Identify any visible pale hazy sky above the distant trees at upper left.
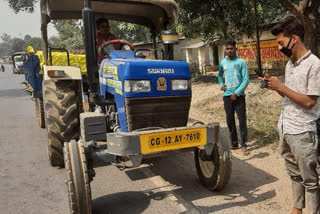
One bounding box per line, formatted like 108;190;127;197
0;0;57;42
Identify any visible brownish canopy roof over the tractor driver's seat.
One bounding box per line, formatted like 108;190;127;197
40;0;178;33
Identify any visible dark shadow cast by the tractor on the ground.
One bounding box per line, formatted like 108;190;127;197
93;124;278;214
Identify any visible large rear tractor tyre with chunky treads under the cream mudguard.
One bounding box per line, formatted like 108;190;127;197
43;80;79;167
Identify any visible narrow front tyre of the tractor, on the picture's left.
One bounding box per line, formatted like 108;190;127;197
64;140;91;214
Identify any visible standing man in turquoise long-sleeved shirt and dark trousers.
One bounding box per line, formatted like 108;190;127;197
218;40;249;155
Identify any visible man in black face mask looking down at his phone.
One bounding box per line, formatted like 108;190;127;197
259;16;320;214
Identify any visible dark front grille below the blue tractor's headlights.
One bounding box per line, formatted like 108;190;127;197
125;95;191;132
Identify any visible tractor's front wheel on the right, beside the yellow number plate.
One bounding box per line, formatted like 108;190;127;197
194;133;232;191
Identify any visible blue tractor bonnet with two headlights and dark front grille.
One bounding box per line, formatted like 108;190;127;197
99;51;191;132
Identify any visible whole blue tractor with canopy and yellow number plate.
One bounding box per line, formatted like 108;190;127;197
40;0;231;214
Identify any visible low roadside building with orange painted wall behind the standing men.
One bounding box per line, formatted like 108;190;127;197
134;24;288;73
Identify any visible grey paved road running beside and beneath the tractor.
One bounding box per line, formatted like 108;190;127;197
0;66;281;214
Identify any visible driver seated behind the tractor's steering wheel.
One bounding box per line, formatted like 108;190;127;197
96;17;120;62
